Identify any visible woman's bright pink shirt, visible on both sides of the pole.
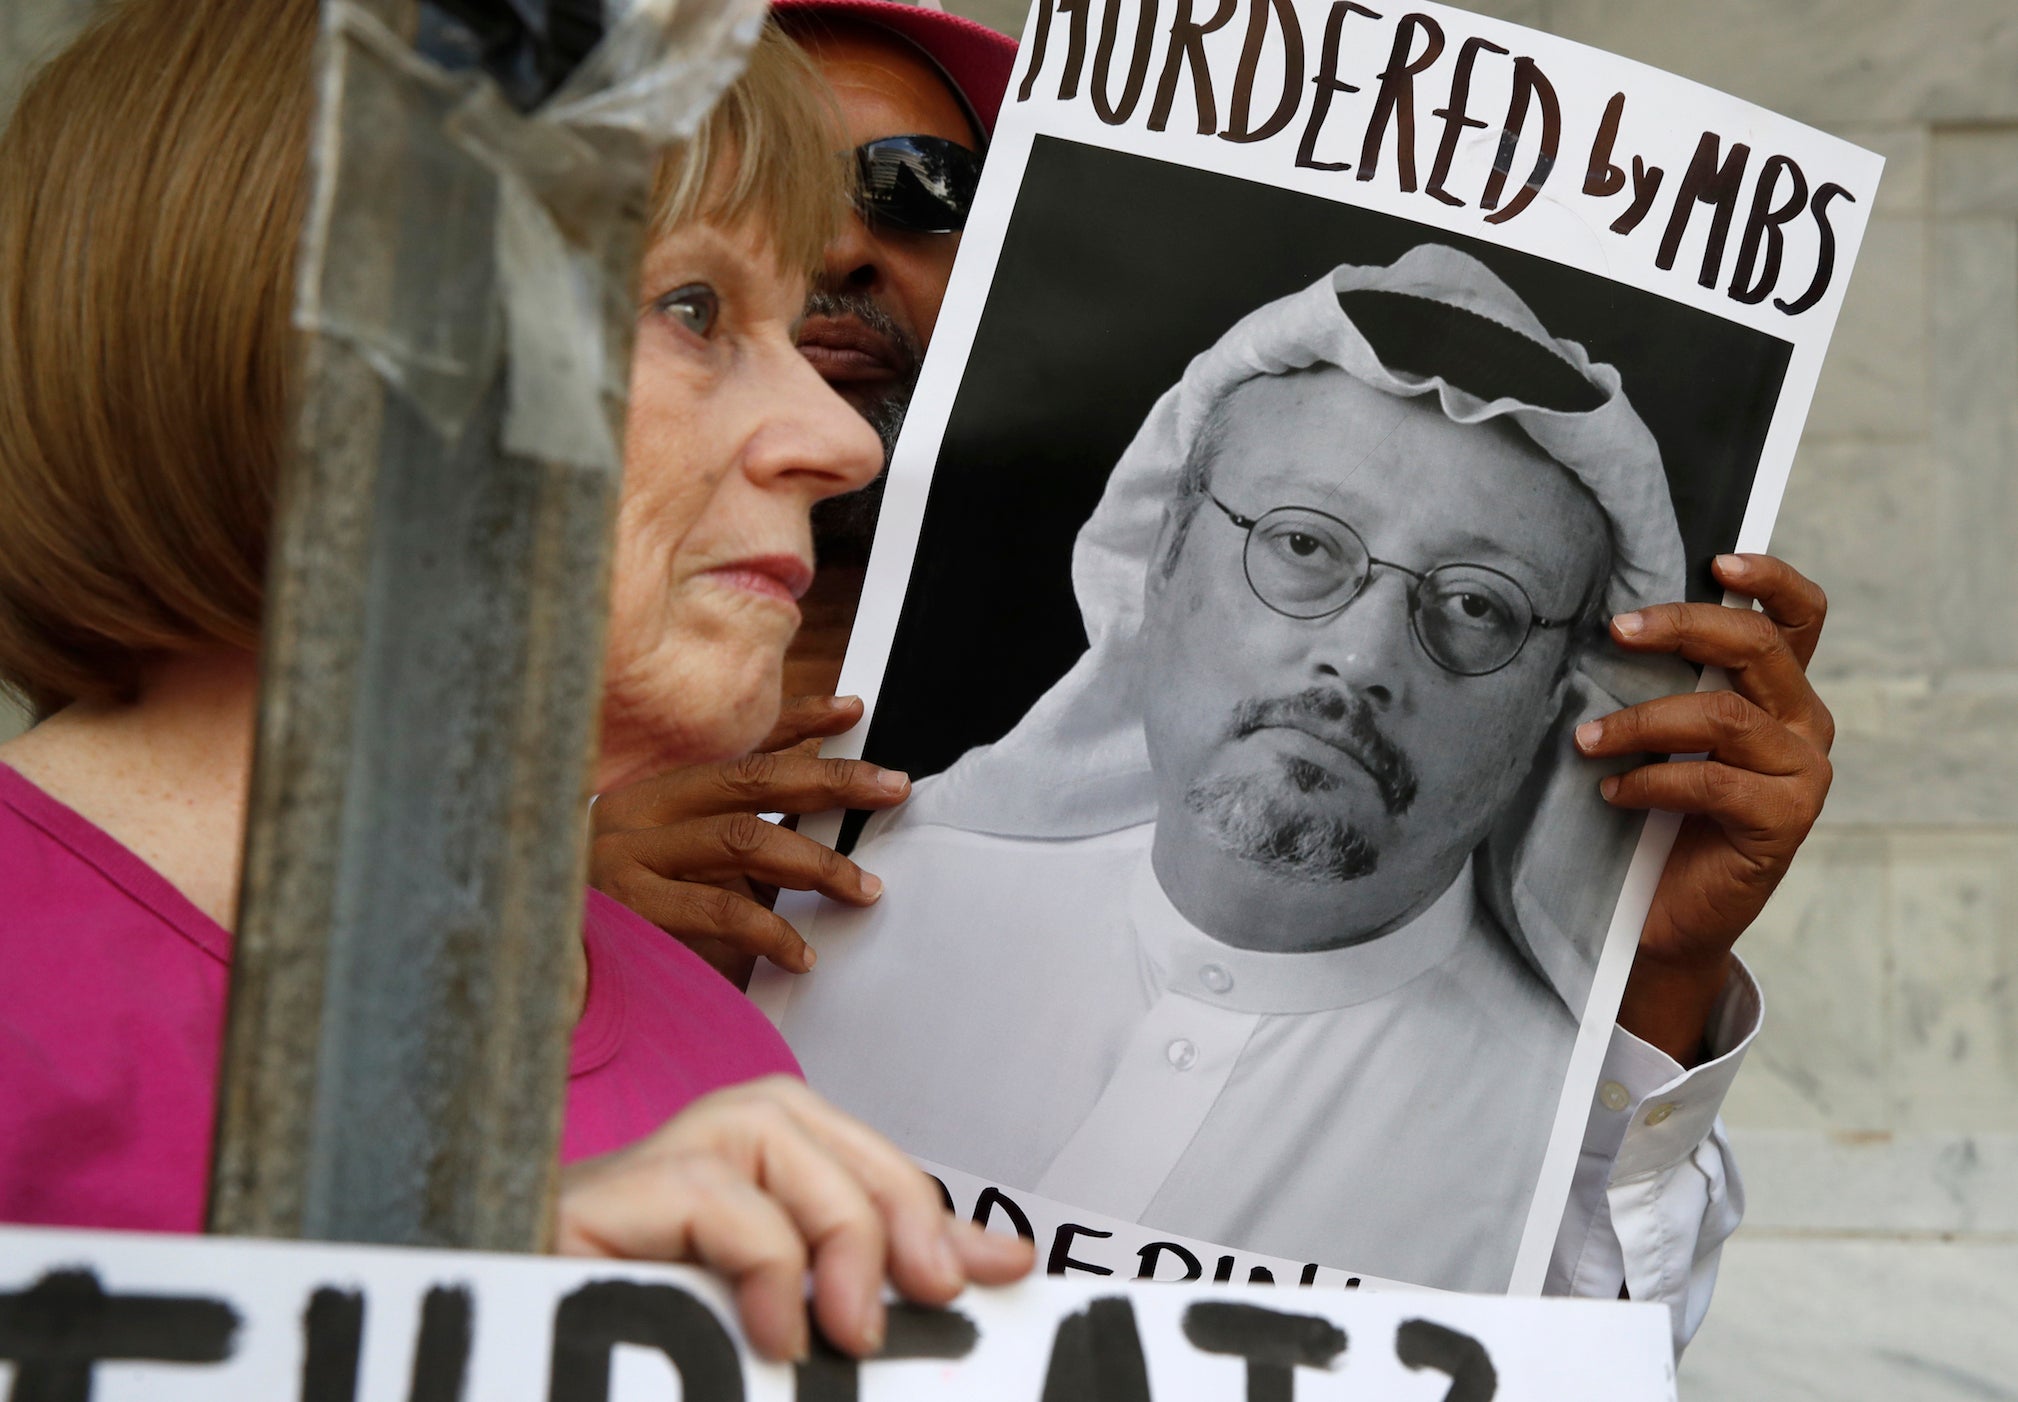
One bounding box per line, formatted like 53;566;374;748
0;765;799;1233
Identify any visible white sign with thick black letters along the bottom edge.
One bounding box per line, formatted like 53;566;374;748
0;1229;1675;1402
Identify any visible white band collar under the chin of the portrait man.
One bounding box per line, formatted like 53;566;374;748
1128;845;1477;1013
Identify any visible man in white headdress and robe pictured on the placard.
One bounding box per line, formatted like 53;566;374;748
783;244;1691;1289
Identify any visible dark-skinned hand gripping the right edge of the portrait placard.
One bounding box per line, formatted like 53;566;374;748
1576;555;1836;1065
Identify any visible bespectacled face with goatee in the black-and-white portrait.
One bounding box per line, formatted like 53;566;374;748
1140;367;1608;934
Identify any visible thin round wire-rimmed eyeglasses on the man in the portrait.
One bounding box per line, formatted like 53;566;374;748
1207;492;1572;676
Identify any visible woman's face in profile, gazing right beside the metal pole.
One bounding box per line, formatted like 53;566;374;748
597;224;882;789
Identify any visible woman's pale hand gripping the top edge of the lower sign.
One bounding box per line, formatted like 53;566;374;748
555;1077;1035;1360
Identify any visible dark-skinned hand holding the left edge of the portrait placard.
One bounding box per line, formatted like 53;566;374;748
589;696;910;984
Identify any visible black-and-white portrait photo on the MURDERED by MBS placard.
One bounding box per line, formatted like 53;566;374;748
781;139;1786;1291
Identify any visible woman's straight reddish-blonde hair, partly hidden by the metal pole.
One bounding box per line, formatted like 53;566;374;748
0;0;848;714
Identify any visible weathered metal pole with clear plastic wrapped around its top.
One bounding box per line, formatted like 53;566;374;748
210;0;761;1251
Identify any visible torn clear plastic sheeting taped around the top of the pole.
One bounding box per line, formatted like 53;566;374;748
295;0;763;472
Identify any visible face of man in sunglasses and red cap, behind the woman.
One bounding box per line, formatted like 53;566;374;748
799;22;977;494
